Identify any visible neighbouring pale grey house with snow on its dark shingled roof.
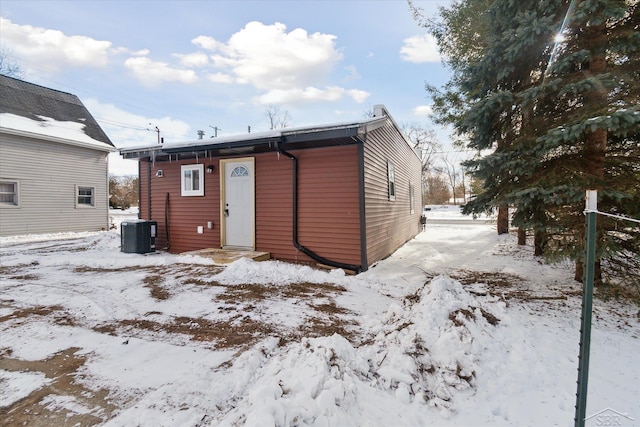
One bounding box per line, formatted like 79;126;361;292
0;76;115;236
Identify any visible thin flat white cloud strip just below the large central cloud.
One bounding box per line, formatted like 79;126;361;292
253;86;370;105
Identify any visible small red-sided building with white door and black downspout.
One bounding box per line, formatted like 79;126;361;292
120;105;422;272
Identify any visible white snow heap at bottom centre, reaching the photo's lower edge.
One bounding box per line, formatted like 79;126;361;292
212;335;369;426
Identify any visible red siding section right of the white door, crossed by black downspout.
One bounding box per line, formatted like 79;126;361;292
256;145;360;265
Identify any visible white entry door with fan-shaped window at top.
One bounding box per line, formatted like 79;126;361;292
220;157;255;249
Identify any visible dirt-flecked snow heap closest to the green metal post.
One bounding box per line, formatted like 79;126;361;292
364;276;499;417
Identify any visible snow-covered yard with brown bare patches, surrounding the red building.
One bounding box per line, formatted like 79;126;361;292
0;207;640;427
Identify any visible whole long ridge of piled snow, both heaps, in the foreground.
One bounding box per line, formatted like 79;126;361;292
202;276;499;426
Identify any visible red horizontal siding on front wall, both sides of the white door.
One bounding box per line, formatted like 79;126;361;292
139;145;360;264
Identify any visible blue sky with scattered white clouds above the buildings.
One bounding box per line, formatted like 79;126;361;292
0;0;450;174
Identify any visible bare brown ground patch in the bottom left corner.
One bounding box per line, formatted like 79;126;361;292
0;348;118;427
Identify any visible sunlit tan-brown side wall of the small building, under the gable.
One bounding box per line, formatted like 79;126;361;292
364;120;422;265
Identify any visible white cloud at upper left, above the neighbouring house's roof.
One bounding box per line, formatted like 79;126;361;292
0;17;115;72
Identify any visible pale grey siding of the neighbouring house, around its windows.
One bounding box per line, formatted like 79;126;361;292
0;133;109;236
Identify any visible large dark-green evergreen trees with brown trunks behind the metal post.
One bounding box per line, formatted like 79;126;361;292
410;0;640;290
